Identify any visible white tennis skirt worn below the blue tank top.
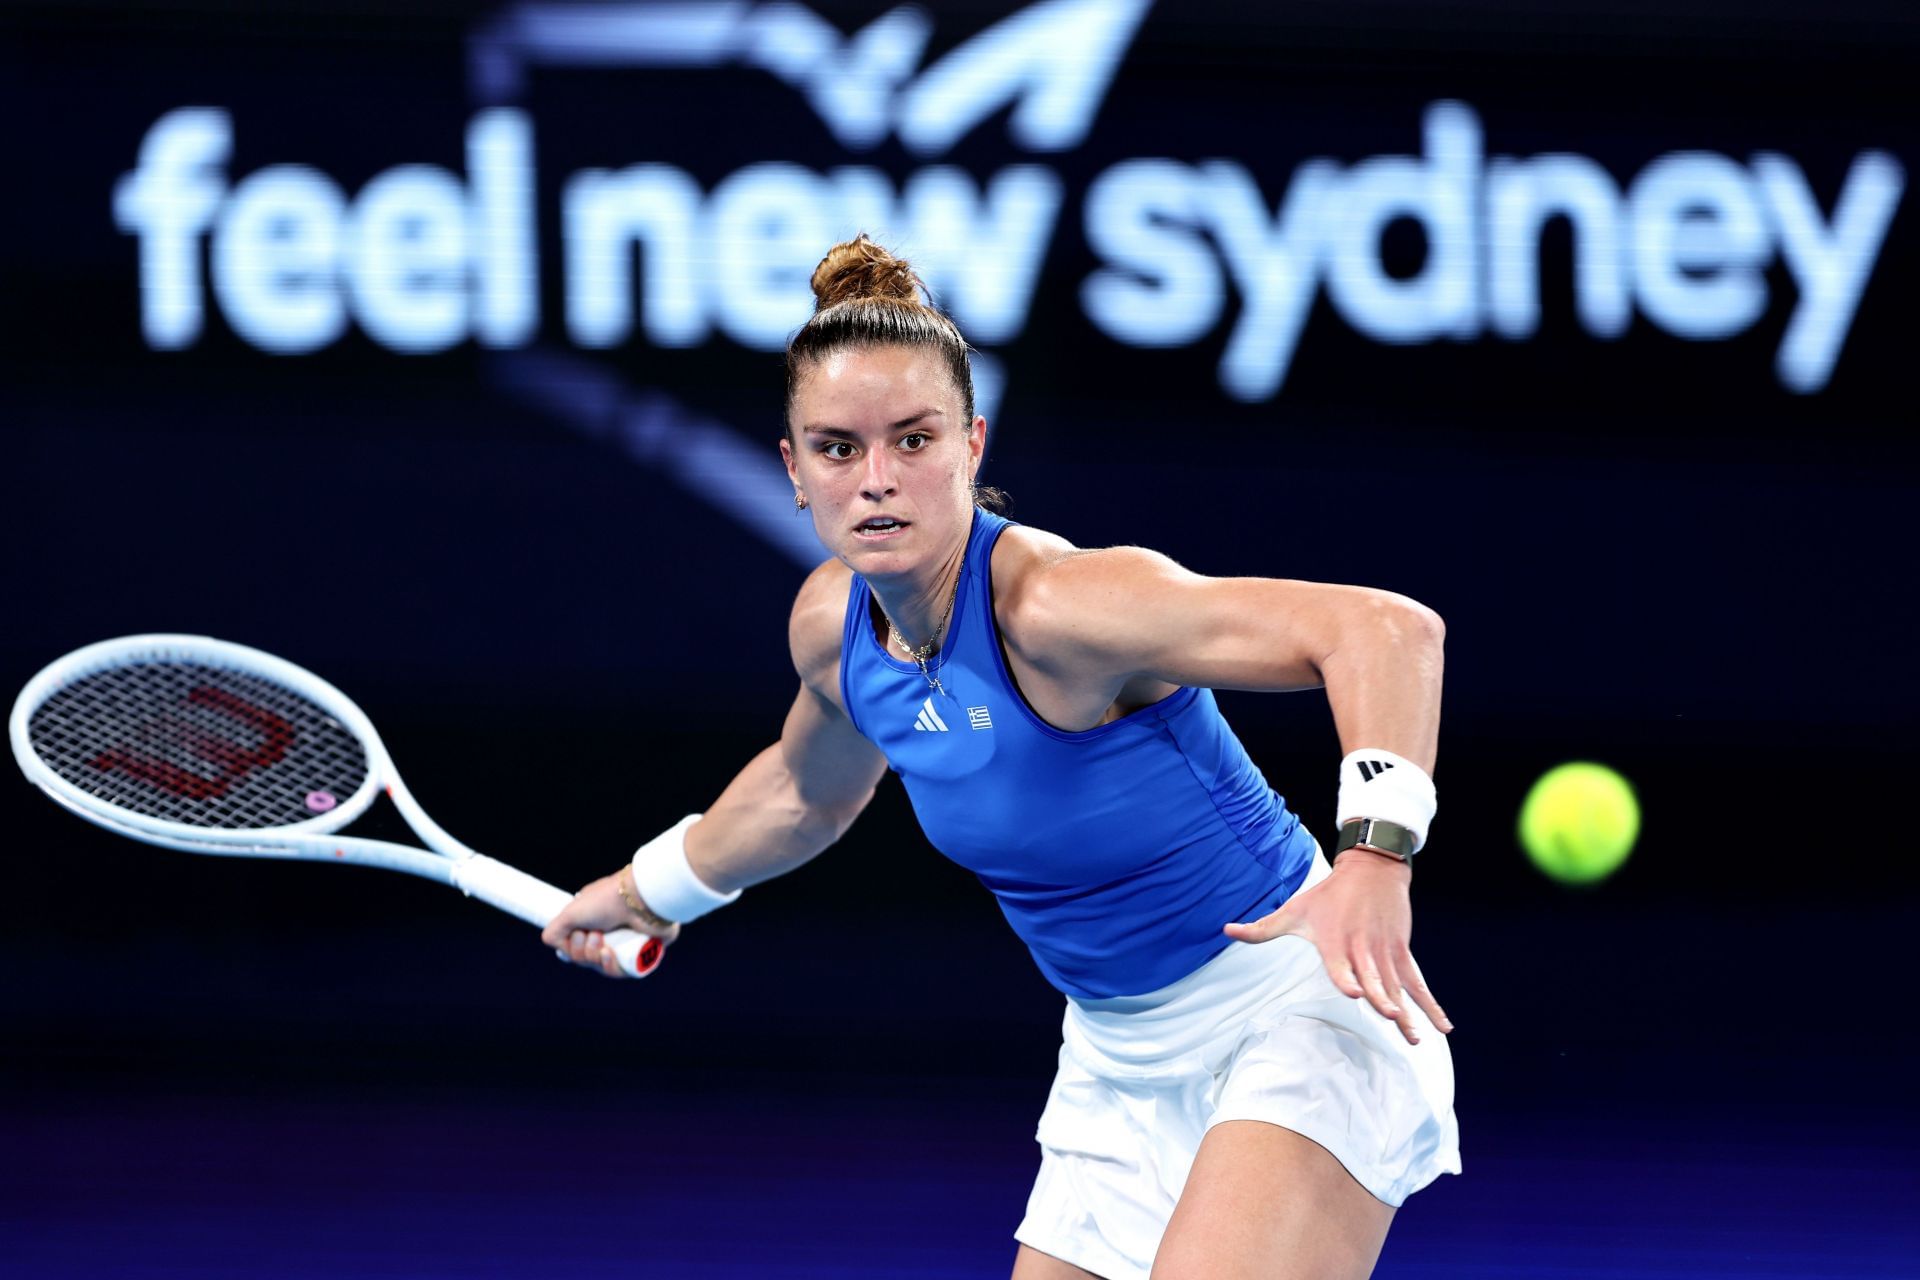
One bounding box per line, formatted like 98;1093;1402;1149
1014;846;1459;1280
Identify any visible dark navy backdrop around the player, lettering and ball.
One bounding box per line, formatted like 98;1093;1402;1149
0;0;1920;1276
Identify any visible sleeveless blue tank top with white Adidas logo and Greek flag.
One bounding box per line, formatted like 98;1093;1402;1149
841;510;1313;1000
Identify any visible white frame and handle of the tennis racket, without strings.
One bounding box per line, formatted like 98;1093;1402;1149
8;633;659;977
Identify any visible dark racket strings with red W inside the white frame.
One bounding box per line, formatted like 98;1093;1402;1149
27;660;369;829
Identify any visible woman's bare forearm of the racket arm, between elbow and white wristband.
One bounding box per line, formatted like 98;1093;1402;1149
687;743;874;892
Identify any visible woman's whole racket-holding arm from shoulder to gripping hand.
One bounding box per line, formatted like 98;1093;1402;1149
541;562;887;977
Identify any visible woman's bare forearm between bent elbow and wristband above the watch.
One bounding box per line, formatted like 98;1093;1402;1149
1319;591;1446;773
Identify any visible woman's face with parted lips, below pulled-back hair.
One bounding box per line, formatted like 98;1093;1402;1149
780;347;987;578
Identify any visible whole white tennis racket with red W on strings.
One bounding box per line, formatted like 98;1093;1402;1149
8;635;664;977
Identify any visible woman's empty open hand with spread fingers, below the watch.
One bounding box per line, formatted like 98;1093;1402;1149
1227;848;1453;1044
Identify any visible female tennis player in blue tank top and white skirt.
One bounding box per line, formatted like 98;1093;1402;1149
543;236;1459;1280
